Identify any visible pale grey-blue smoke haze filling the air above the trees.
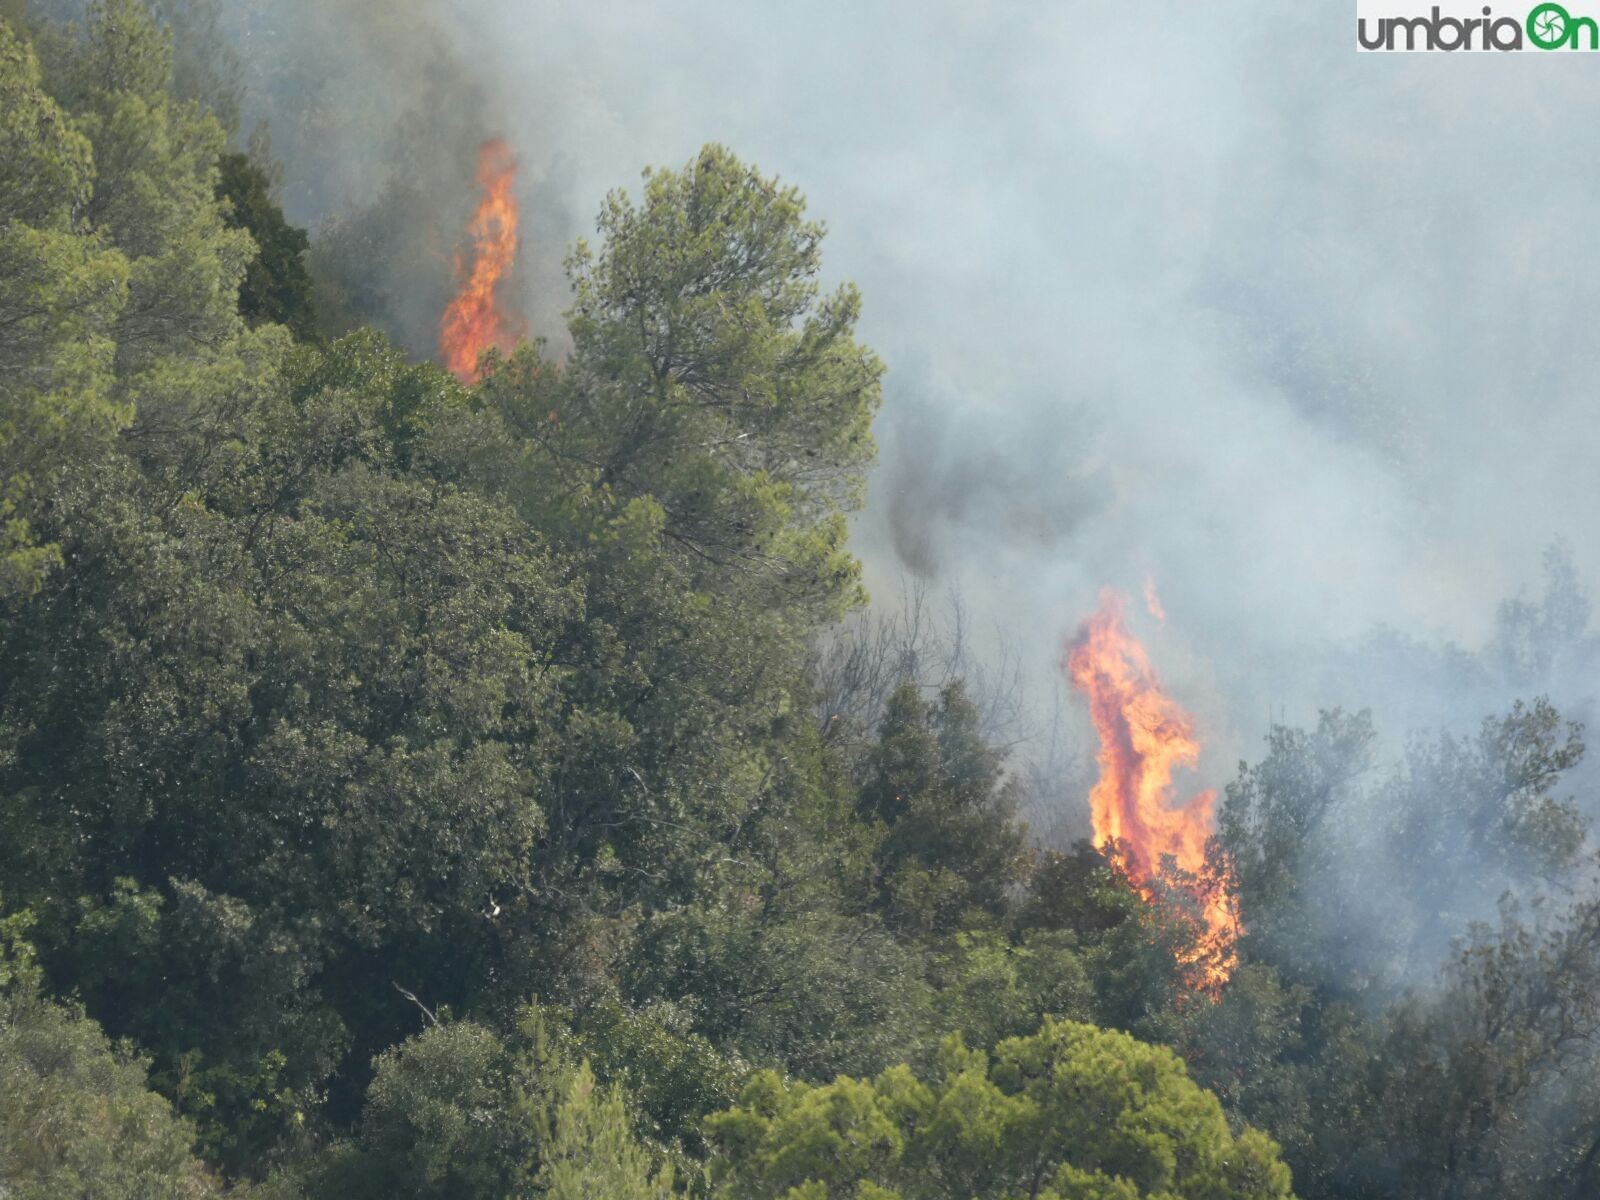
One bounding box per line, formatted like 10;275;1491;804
219;0;1600;779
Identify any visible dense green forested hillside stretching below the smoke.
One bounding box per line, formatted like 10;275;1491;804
0;0;1600;1200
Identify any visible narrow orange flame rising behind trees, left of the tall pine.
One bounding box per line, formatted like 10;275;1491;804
438;138;523;384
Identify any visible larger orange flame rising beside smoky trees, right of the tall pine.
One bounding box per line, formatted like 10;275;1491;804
1064;589;1240;989
